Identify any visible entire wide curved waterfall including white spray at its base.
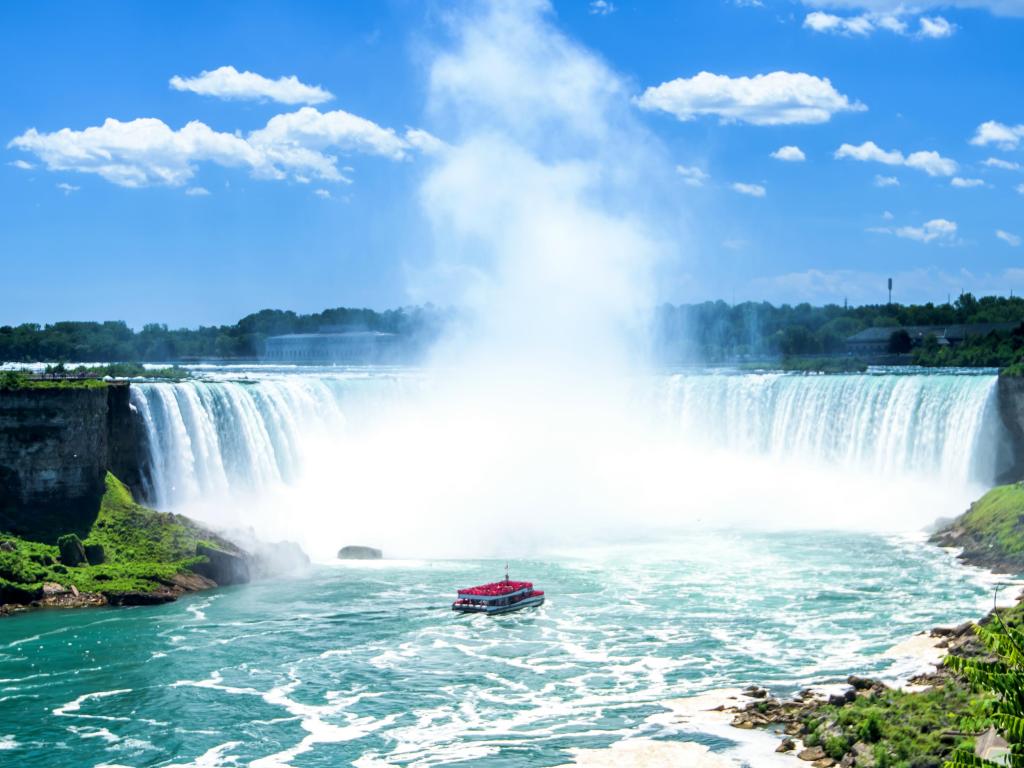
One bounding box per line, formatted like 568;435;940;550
133;374;1002;558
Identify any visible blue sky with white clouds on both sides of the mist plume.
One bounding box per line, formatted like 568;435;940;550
0;0;1024;326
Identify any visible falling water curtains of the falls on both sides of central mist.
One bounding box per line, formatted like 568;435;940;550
132;373;1001;518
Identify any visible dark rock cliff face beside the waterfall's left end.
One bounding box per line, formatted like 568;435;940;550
0;385;140;541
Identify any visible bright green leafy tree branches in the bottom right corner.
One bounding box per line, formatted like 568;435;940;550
945;611;1024;768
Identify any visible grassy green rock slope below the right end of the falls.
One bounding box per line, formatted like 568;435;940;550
932;482;1024;572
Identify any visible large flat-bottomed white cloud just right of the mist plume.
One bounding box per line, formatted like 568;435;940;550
637;72;867;125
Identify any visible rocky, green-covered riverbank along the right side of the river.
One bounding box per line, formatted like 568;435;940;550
696;482;1024;768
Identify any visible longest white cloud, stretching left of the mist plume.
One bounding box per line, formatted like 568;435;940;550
7;106;429;187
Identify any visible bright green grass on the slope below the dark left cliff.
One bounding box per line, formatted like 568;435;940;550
0;473;209;602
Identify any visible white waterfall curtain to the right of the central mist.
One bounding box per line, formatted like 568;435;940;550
658;373;1002;483
